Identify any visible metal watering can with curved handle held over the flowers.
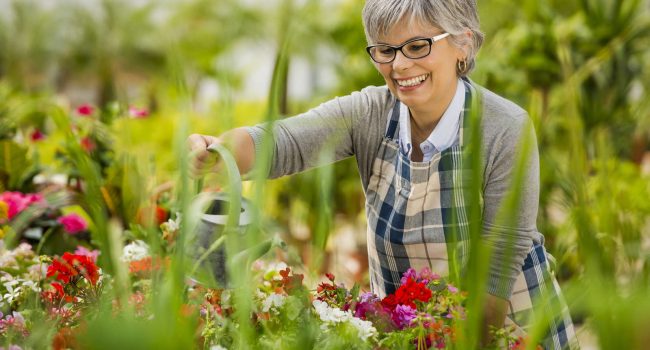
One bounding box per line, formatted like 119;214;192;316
190;144;286;288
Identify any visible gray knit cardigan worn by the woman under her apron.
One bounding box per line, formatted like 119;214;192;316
248;84;543;299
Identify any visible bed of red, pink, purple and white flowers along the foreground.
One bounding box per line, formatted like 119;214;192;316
0;189;540;349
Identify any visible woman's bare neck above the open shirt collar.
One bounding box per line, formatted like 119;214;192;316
409;80;458;139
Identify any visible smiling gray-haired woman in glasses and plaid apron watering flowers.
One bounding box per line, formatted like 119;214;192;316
188;0;577;349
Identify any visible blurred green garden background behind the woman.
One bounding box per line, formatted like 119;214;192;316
0;0;650;347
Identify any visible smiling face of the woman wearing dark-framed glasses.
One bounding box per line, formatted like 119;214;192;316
375;20;466;112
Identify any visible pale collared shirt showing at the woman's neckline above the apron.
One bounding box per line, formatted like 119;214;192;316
399;79;465;162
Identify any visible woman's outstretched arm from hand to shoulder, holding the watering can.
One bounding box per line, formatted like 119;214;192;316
188;87;394;184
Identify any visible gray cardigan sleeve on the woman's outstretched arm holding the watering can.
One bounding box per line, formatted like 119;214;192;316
247;87;387;178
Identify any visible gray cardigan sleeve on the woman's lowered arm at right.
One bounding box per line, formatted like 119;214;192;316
483;112;541;299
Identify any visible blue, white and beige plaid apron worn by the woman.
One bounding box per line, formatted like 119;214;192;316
366;80;578;349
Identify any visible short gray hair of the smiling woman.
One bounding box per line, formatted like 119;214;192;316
362;0;484;76
